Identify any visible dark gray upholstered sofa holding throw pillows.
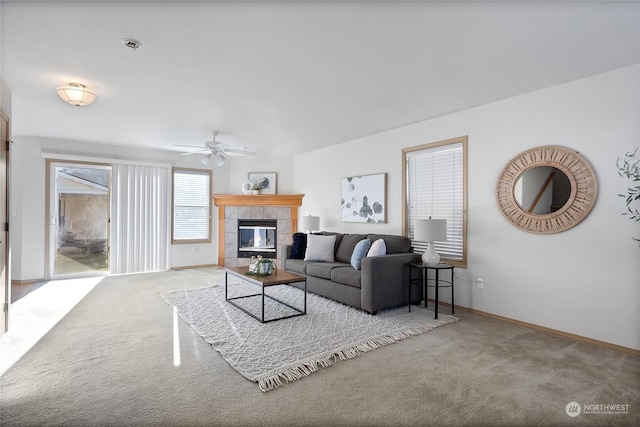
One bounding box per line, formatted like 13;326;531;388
281;232;422;314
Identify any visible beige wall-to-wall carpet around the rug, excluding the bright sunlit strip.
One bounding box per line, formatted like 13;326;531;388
0;268;640;427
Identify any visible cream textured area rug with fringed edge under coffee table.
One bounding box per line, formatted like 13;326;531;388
160;283;458;392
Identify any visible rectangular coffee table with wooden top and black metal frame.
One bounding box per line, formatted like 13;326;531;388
224;267;307;323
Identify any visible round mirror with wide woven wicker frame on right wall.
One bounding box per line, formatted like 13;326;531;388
496;145;597;234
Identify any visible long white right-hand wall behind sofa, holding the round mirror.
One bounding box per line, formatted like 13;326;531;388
293;65;640;349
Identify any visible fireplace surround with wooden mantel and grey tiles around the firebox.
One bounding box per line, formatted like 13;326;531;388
212;194;304;267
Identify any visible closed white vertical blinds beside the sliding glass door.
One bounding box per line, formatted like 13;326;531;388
111;164;171;274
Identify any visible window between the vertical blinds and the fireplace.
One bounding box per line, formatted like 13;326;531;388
171;169;211;243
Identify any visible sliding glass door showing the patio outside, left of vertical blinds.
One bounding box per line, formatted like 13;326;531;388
49;163;111;278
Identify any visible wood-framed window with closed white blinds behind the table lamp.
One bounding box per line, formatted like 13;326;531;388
402;136;467;268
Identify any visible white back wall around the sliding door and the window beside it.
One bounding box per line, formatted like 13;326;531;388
10;136;229;280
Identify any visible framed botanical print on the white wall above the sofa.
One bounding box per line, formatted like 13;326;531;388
341;173;387;224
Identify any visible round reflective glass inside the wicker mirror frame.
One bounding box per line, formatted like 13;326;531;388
513;166;571;215
